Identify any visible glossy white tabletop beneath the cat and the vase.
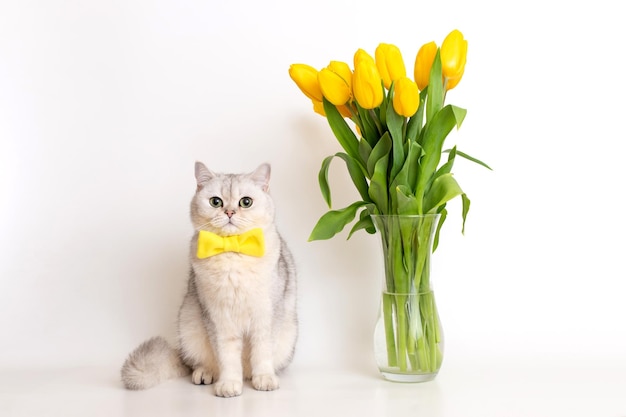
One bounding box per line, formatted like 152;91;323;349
0;357;626;417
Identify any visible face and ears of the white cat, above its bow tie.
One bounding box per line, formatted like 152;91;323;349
191;162;274;236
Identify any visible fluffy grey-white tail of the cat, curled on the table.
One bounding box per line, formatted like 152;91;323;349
121;336;190;390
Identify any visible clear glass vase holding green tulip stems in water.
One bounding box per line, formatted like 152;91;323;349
372;214;444;382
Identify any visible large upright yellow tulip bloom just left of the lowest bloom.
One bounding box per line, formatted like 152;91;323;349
352;49;383;109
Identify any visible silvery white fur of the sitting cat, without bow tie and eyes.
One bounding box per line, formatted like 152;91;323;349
121;162;298;397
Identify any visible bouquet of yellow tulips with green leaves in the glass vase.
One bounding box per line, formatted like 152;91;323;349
289;30;489;374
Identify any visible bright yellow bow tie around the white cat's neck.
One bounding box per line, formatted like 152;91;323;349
197;228;265;259
